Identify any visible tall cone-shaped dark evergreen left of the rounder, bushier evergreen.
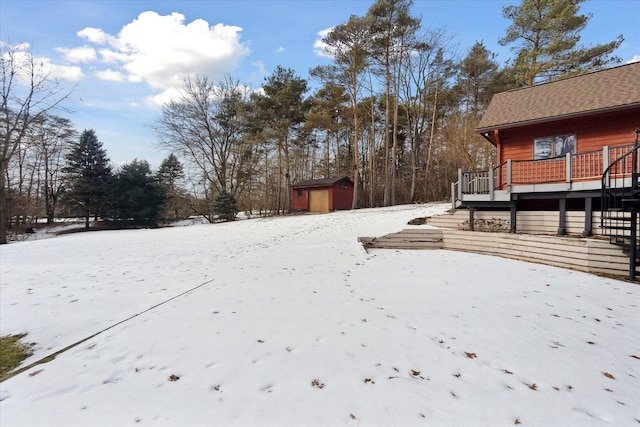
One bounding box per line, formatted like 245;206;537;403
64;129;111;228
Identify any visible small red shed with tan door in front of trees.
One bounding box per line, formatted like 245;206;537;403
291;176;353;212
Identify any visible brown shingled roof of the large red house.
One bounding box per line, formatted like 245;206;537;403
476;62;640;133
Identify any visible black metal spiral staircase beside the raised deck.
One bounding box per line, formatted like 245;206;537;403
600;129;640;281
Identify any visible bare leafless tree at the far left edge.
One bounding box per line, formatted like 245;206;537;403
0;42;73;244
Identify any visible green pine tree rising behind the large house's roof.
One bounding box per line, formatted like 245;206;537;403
500;0;624;86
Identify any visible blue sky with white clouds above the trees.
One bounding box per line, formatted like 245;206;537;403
0;0;640;167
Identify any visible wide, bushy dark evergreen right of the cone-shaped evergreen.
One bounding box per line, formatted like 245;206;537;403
110;160;166;224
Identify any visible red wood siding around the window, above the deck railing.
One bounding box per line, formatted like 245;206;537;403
498;109;640;163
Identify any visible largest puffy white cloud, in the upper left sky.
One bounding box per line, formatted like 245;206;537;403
78;11;249;100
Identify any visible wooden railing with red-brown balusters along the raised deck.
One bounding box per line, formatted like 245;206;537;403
452;144;633;200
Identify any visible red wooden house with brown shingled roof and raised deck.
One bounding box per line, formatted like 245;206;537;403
452;63;640;280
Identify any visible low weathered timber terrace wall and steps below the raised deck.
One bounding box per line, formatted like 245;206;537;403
358;228;629;279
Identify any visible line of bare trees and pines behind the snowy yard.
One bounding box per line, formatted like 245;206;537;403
0;0;623;244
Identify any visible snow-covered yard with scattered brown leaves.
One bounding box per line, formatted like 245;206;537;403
0;204;640;426
